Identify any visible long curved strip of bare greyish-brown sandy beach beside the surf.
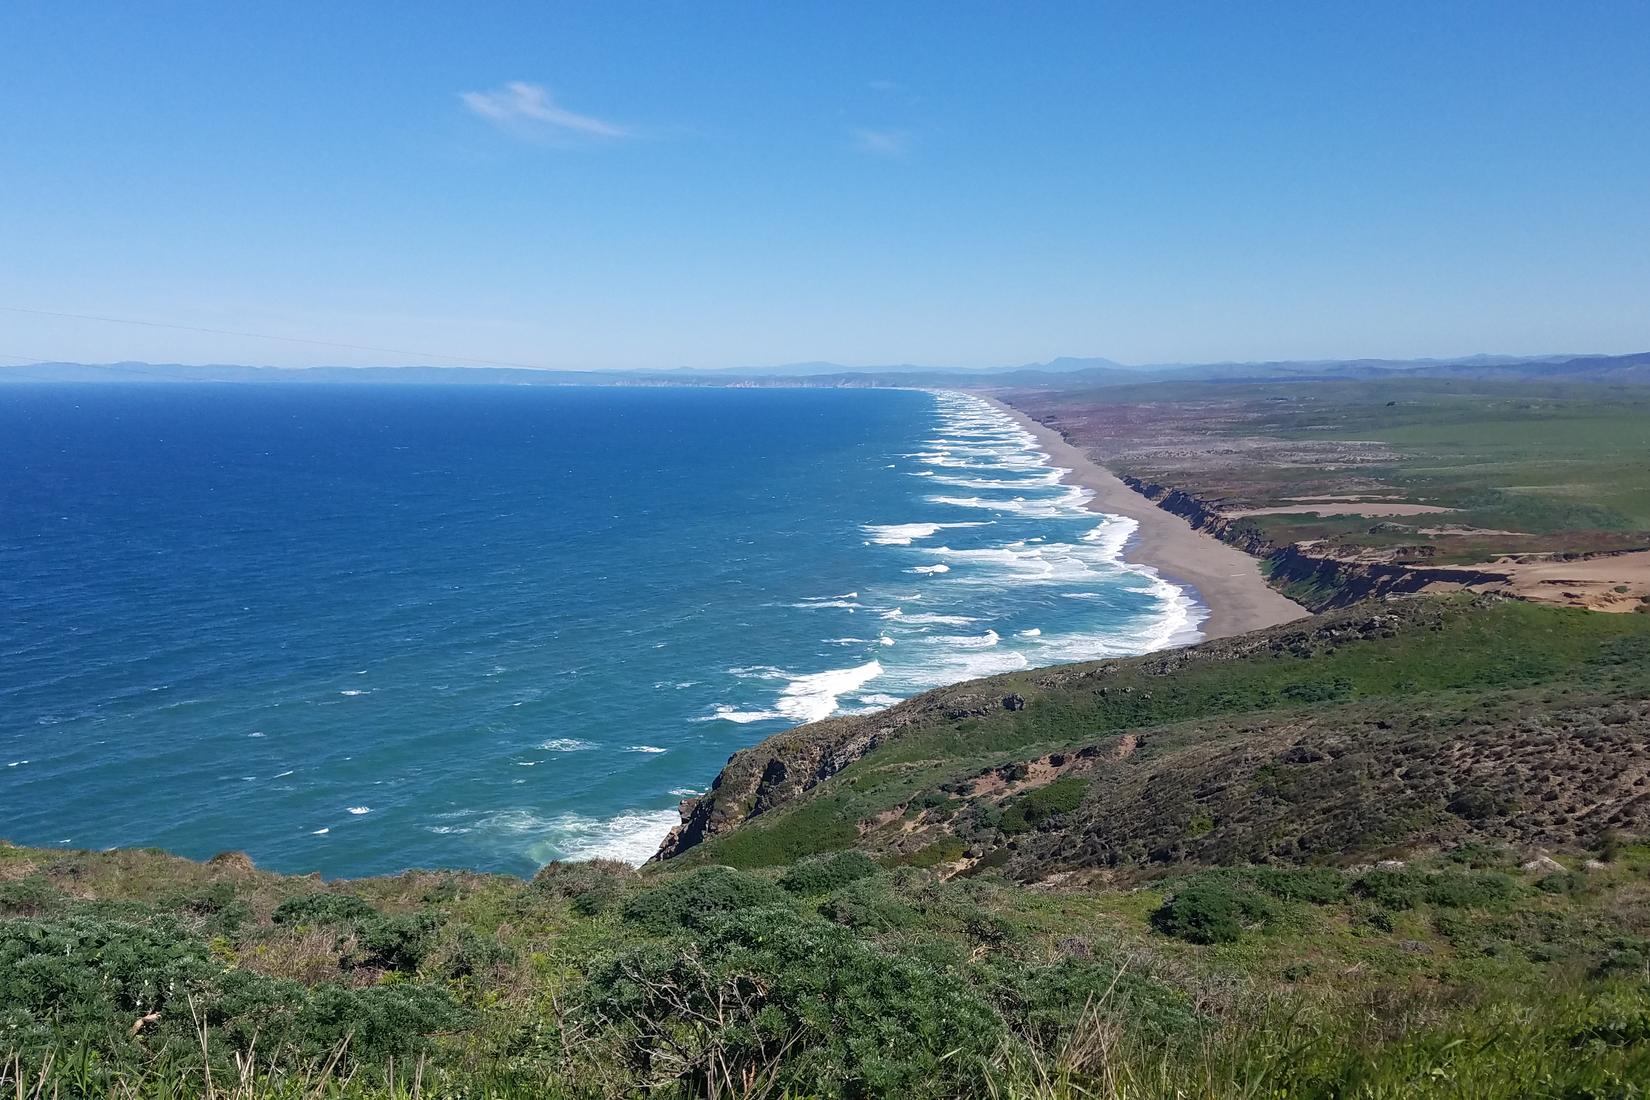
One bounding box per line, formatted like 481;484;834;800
974;391;1312;640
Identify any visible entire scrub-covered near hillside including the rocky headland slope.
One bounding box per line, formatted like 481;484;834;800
0;599;1650;1100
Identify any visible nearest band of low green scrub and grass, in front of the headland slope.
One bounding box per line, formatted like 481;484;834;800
0;838;1650;1100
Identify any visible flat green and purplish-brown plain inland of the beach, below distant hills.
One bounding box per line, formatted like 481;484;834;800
1008;379;1650;562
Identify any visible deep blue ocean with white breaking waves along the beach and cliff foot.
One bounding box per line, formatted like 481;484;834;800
0;384;1203;876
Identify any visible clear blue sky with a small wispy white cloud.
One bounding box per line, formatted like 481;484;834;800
0;0;1650;368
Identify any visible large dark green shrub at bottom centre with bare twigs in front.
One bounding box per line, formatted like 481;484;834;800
578;909;1003;1100
